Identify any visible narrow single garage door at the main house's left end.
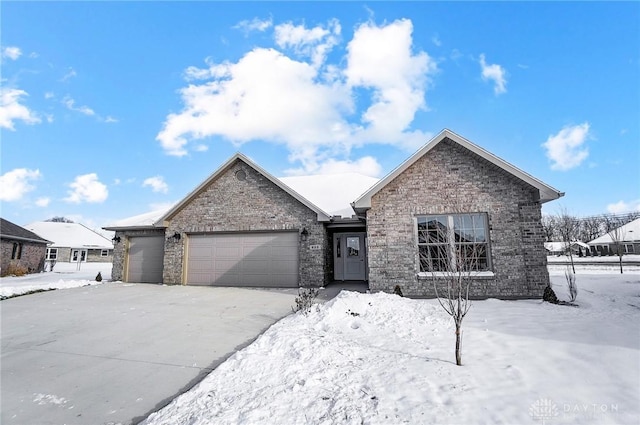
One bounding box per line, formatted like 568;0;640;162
126;236;164;283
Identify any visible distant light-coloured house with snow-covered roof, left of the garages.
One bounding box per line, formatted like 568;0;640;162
25;221;113;263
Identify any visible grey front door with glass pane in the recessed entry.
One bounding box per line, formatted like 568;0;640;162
333;233;367;280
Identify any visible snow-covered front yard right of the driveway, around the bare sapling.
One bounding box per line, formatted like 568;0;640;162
144;266;640;425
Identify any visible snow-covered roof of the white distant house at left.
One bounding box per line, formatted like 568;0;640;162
25;221;113;249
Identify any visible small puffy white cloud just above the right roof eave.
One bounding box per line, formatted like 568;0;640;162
542;122;590;171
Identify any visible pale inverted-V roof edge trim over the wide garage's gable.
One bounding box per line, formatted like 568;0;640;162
154;152;331;226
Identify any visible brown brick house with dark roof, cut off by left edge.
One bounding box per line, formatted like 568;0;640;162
0;218;51;276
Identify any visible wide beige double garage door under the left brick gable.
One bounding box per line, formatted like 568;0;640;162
187;232;298;288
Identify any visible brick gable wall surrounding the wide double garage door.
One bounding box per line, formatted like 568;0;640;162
163;160;330;286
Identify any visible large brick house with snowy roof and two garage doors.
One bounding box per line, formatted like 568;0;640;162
105;130;563;298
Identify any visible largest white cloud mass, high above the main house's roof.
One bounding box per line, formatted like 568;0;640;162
156;20;437;171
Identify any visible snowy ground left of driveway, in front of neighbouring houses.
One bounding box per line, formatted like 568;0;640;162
0;262;112;299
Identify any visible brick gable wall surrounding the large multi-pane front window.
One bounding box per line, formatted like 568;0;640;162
367;139;549;298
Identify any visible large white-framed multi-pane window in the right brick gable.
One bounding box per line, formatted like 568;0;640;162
417;213;491;272
